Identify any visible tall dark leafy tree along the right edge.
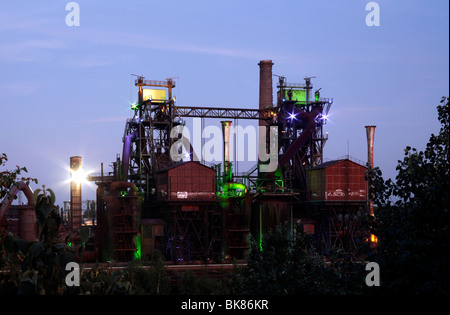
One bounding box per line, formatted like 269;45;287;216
368;97;450;294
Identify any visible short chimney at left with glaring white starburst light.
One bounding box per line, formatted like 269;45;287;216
70;156;81;231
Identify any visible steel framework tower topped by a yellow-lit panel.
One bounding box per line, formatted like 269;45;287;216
121;76;182;198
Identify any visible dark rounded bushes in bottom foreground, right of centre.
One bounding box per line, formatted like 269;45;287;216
232;225;364;295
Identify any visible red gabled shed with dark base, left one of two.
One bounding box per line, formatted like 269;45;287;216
154;161;221;261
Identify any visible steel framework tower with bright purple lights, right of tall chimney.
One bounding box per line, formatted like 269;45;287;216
275;76;333;193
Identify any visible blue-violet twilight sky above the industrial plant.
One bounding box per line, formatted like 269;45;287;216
0;0;449;206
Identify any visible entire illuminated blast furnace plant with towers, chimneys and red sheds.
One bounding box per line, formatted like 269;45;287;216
0;60;376;264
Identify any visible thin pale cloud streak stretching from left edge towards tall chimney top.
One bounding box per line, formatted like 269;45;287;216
0;4;286;68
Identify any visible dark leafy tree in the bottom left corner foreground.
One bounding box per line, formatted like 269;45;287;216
0;185;76;295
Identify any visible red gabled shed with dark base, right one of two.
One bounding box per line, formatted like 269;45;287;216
294;156;369;256
